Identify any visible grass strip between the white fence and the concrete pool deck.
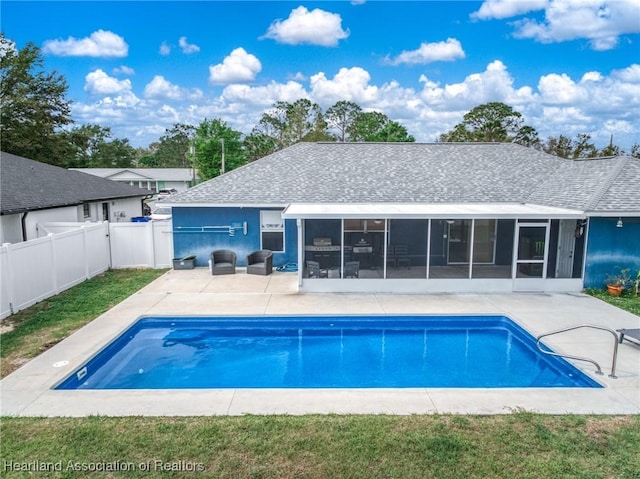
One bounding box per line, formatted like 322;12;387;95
0;269;166;377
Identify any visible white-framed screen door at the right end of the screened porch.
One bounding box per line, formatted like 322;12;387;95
513;223;549;291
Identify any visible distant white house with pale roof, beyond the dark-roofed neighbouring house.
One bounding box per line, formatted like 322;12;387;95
70;168;200;193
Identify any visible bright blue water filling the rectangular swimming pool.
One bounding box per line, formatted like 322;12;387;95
57;316;600;389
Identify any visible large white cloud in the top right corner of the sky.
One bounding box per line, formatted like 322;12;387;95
513;0;640;51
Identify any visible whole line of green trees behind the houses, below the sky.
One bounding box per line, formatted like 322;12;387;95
0;33;640;183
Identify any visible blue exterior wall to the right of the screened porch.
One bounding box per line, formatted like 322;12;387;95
584;218;640;288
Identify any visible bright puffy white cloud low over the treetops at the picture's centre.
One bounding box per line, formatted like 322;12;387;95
310;67;378;106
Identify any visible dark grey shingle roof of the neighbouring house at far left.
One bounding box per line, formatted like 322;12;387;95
0;152;152;215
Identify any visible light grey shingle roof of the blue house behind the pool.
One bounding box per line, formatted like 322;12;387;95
170;143;640;217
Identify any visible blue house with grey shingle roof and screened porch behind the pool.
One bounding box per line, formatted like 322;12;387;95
162;143;640;292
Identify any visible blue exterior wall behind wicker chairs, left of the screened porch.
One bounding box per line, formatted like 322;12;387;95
172;206;298;266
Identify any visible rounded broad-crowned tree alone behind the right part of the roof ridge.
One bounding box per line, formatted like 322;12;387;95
440;102;539;146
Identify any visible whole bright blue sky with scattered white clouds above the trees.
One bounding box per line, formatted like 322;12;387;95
1;0;640;152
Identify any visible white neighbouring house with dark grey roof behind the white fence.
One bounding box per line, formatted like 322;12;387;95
0;152;153;244
